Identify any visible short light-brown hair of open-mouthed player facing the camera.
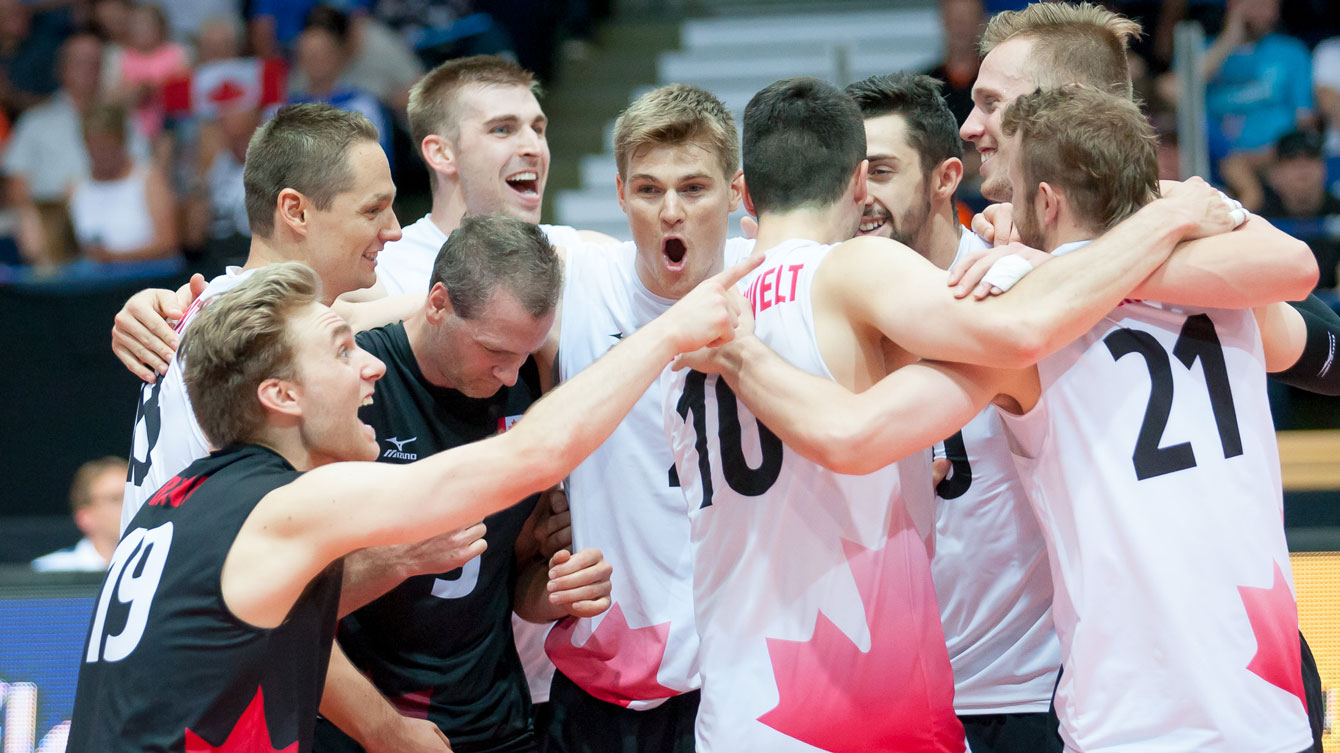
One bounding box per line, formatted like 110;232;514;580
614;83;740;180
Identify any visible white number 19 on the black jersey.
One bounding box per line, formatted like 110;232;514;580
84;523;172;663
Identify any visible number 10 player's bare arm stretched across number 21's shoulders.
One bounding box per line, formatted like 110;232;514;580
836;182;1233;368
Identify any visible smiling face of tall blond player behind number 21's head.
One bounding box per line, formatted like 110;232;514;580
958;38;1037;201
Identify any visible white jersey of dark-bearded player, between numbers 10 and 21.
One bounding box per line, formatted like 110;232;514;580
931;232;1061;714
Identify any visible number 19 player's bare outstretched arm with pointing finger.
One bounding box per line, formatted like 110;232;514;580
222;249;762;627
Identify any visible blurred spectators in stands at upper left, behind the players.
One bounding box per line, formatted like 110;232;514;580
0;0;608;272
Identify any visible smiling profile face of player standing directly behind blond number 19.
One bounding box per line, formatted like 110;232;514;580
304;141;401;300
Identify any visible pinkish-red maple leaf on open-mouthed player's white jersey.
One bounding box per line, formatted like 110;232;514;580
544;604;679;707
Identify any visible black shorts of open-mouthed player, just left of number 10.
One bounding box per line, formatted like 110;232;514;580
539;671;698;753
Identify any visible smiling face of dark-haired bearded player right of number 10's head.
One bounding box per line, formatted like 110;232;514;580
858;113;930;248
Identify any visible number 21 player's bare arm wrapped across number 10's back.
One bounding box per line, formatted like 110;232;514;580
683;336;1007;473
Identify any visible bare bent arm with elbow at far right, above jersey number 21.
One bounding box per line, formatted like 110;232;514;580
1131;214;1317;308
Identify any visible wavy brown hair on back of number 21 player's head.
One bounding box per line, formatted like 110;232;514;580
1001;86;1159;230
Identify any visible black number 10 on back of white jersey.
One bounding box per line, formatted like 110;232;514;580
675;371;783;508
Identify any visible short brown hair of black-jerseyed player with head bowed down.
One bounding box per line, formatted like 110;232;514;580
429;214;563;319
